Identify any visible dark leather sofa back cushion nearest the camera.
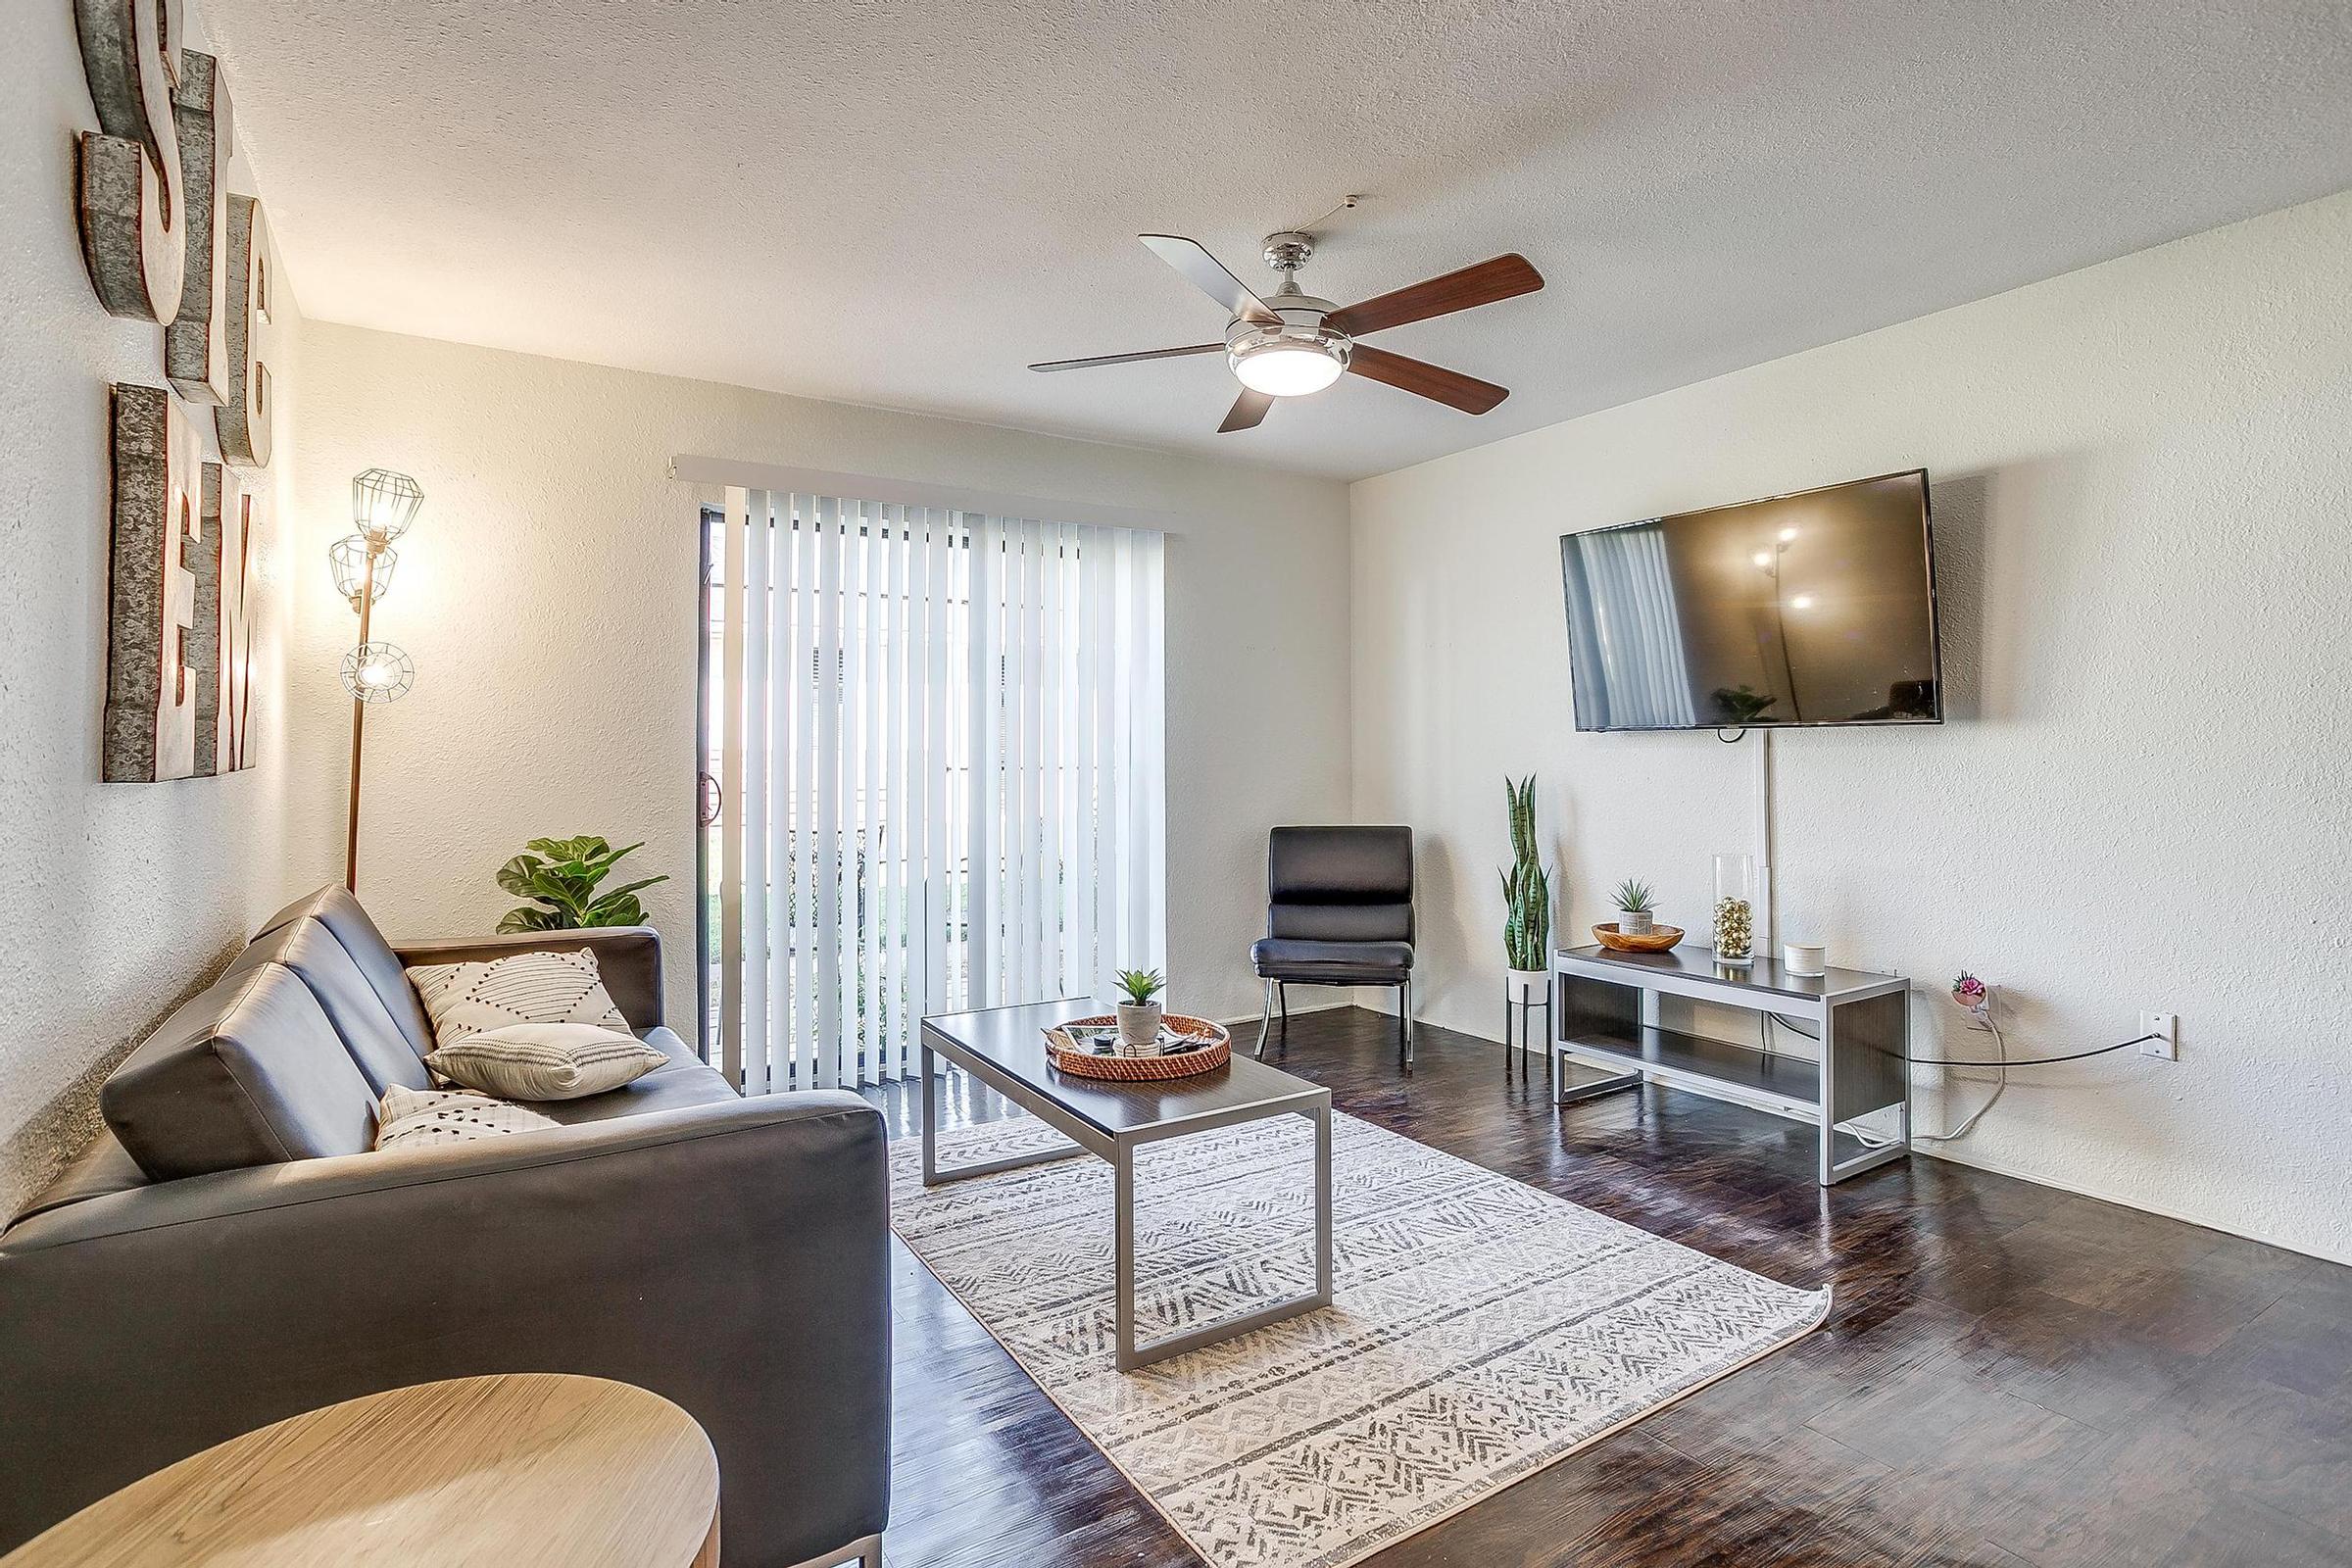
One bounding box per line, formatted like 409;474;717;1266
99;964;376;1180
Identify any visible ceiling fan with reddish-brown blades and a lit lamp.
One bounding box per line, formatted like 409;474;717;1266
1030;228;1543;432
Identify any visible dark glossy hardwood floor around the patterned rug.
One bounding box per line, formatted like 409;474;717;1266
875;1008;2352;1568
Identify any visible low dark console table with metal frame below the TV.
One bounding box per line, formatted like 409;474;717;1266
1547;948;1910;1187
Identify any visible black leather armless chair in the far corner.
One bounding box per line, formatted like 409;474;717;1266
1249;827;1413;1072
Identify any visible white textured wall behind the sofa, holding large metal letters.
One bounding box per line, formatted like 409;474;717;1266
0;5;299;1218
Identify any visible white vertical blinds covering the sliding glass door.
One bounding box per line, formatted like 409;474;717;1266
708;489;1166;1093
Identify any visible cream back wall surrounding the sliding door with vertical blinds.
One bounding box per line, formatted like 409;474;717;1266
289;326;1348;1020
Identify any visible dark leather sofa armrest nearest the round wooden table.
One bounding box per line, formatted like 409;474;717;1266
0;1093;892;1566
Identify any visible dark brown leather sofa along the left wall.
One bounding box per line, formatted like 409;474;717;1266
0;889;889;1568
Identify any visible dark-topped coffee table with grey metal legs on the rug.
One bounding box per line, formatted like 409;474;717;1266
922;999;1331;1373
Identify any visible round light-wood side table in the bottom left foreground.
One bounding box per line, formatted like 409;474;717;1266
0;1373;719;1568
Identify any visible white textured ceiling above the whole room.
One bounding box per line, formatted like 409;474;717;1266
202;0;2352;477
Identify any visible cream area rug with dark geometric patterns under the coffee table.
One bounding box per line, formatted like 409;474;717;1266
892;1114;1830;1568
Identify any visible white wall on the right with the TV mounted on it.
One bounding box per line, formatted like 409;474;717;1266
1352;195;2352;1260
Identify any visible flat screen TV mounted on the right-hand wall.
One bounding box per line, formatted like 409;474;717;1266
1559;467;1942;729
